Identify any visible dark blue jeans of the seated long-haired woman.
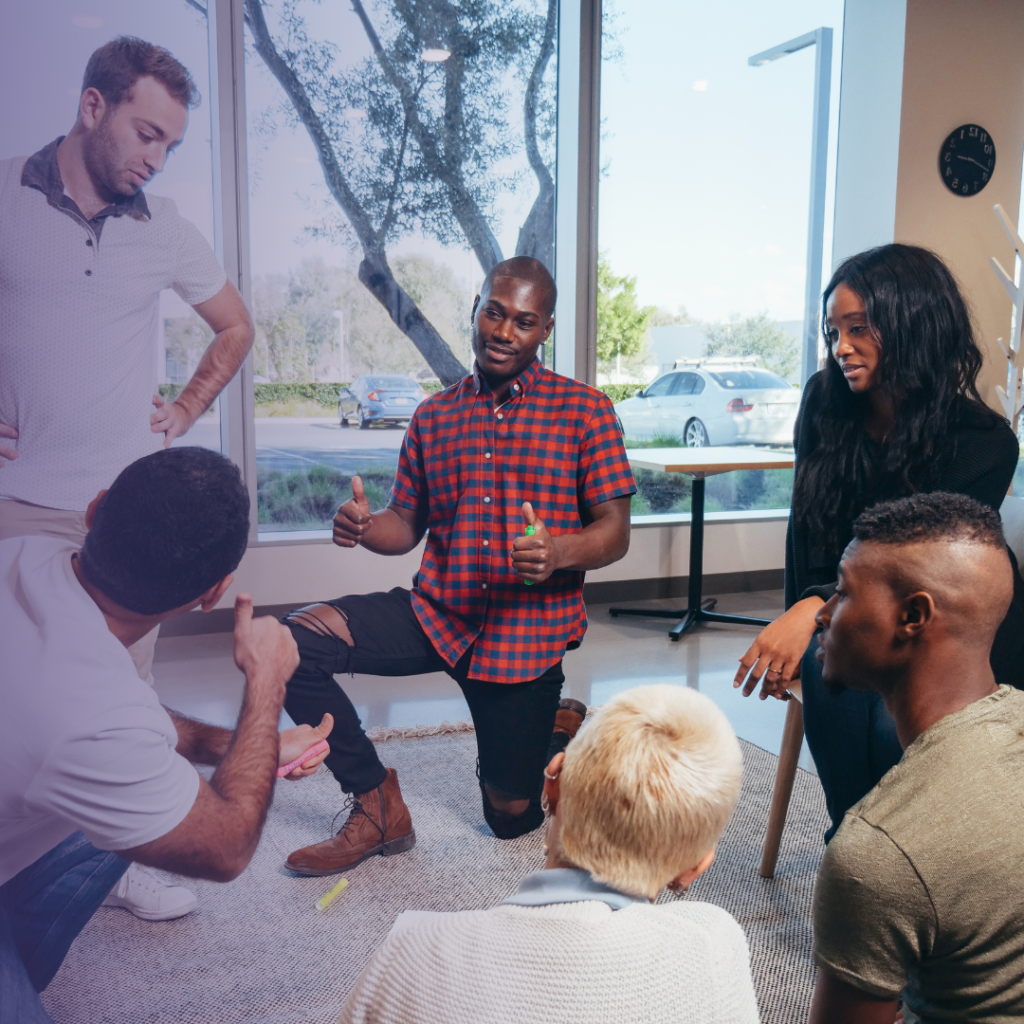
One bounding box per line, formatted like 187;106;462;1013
800;634;903;843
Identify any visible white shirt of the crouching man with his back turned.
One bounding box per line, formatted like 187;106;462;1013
0;536;199;885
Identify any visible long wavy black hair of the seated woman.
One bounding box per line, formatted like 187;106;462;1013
793;245;995;551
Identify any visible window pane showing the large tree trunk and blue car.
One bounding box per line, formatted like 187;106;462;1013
246;0;557;535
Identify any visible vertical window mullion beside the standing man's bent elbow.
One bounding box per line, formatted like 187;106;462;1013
207;0;258;543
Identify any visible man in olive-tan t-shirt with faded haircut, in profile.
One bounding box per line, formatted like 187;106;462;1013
811;493;1024;1024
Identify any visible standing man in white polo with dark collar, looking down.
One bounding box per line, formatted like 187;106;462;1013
0;37;253;920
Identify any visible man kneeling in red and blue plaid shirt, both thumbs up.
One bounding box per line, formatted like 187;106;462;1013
284;257;636;874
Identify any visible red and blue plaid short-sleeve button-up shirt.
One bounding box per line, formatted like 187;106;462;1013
391;360;636;683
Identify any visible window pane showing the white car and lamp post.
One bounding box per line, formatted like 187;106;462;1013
598;0;843;514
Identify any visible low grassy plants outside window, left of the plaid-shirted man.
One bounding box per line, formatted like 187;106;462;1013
256;466;394;531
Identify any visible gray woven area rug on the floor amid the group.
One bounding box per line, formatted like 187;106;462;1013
43;734;825;1024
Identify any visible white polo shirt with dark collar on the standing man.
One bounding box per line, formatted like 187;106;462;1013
0;140;226;511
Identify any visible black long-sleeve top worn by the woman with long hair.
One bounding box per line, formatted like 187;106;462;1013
785;372;1024;689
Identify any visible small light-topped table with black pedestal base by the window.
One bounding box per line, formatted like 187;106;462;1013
609;446;794;640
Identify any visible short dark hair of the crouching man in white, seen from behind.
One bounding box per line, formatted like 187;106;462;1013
79;447;249;615
